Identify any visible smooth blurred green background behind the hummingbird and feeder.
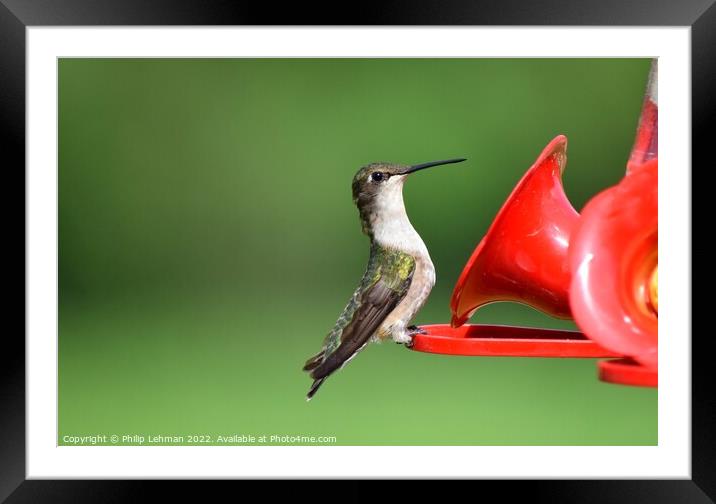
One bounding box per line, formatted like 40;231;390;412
58;59;657;445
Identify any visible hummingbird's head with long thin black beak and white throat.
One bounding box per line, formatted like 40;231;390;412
353;158;465;234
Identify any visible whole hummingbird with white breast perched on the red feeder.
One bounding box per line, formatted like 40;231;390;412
303;158;465;400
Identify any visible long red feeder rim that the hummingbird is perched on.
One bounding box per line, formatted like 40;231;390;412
411;324;622;358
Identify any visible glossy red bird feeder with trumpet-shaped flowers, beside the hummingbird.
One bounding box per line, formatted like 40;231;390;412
411;61;658;387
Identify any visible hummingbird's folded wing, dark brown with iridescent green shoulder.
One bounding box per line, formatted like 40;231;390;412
304;250;415;399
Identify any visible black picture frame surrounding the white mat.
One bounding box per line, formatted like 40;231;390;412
0;0;704;503
